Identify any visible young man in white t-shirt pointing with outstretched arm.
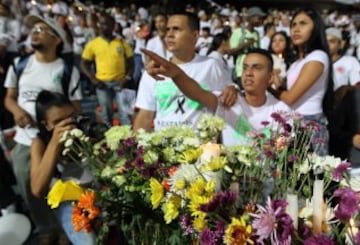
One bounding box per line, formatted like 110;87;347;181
144;49;291;145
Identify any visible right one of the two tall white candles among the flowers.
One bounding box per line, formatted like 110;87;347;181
312;180;324;234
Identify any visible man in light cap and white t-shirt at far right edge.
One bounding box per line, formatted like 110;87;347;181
326;27;360;90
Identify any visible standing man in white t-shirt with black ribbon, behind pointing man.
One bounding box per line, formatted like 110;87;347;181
134;12;235;131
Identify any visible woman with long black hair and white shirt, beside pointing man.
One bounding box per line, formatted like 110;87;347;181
270;8;333;155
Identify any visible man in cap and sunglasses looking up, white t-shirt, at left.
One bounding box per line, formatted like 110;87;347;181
5;15;81;244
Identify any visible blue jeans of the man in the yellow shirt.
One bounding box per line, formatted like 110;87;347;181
96;81;131;127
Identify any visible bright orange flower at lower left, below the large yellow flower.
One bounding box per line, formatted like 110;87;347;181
72;191;100;232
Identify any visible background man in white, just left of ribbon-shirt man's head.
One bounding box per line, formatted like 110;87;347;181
146;13;171;62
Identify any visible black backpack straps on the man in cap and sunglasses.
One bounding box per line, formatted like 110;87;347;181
12;54;80;97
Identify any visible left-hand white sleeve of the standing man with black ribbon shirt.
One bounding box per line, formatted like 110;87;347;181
135;71;156;111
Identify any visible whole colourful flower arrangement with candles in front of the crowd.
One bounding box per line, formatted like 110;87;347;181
59;113;360;245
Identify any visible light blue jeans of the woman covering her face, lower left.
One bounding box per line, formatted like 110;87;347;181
54;201;96;245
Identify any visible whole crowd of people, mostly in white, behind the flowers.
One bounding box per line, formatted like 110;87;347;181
0;0;360;244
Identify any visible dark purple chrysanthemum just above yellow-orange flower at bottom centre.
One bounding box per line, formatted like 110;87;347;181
199;191;236;212
